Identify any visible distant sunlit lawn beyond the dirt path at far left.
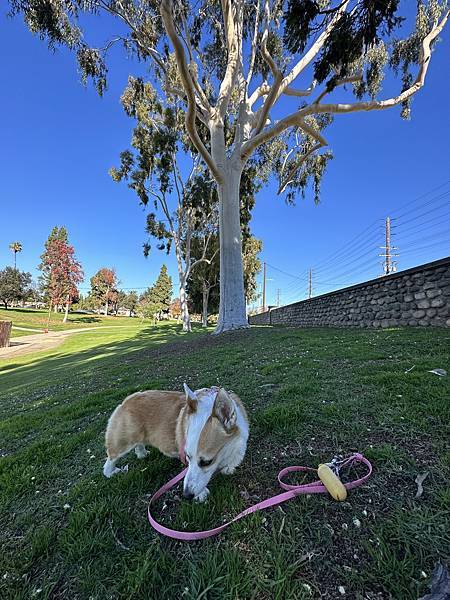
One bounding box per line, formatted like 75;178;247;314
0;308;139;337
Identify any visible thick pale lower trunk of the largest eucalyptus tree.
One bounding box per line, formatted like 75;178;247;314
215;165;249;333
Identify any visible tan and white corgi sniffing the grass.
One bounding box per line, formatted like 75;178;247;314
103;384;249;502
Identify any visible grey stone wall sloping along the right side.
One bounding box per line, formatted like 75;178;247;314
249;257;450;327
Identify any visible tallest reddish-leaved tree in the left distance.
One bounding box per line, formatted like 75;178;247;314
39;229;84;323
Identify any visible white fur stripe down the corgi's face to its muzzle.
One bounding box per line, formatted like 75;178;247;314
183;386;218;497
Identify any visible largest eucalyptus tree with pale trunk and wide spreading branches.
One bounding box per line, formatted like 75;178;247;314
10;0;449;331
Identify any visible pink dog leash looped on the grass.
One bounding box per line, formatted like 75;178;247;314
148;453;372;541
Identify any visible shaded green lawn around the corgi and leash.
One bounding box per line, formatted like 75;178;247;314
0;324;450;600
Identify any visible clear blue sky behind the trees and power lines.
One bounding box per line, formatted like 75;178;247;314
0;3;450;304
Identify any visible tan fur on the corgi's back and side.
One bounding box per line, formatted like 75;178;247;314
105;390;186;460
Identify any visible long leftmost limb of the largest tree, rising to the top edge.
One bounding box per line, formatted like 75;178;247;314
160;0;223;183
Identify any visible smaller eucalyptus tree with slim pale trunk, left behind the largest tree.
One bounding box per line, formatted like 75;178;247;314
110;77;217;331
